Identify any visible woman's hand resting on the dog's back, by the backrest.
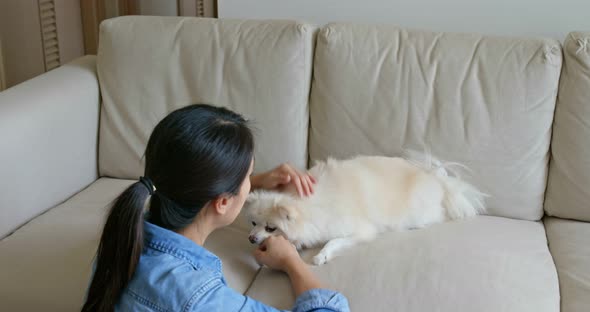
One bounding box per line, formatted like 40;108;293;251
250;163;316;197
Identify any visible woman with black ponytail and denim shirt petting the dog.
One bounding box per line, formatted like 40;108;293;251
82;105;348;311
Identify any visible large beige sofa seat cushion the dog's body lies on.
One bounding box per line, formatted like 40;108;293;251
247;216;559;312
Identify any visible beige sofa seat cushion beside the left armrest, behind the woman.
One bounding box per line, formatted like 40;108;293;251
0;178;259;311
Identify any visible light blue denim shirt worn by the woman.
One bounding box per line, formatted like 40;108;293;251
115;221;349;312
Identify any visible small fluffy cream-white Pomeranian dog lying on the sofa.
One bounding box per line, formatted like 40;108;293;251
245;152;486;265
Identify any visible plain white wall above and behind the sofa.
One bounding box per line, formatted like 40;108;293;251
218;0;590;39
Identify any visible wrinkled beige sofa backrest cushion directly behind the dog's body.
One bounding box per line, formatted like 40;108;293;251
309;24;562;220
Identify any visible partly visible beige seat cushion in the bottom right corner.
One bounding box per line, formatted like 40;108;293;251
545;218;590;312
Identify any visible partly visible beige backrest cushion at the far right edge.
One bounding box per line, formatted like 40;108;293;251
545;32;590;221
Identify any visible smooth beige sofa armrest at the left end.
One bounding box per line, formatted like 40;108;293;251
0;56;100;239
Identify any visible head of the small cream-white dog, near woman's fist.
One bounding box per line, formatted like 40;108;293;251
244;191;299;244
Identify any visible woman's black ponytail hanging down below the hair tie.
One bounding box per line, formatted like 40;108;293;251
82;178;153;312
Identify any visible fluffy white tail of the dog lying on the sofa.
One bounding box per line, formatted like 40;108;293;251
404;150;488;220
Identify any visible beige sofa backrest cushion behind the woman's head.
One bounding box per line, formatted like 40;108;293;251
97;16;314;178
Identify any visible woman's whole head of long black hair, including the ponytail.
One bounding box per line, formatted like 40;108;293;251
82;104;254;311
